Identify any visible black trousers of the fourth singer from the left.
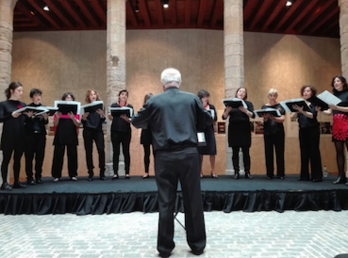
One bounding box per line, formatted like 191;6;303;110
83;129;105;176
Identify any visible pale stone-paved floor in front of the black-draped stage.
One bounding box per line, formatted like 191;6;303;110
0;211;348;258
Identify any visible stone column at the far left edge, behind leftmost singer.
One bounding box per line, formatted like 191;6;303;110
0;0;17;184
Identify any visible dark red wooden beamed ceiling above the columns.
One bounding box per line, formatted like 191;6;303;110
13;0;339;38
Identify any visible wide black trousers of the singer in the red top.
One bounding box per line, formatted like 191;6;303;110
52;144;77;178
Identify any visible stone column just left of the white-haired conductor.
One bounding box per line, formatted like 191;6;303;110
106;0;126;175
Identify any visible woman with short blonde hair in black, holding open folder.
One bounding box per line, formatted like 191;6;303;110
262;89;285;179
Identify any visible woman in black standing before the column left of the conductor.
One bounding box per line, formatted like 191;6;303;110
109;90;134;180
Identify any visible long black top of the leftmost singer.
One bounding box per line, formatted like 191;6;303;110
0;100;27;150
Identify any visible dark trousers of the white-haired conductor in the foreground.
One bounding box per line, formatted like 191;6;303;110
155;148;206;253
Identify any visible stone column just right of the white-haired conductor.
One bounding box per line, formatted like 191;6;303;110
224;0;244;175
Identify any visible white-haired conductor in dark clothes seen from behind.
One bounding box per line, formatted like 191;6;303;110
132;68;211;257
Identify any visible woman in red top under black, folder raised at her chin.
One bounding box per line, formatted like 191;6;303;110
52;92;80;182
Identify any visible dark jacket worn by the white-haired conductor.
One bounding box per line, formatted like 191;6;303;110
132;88;212;151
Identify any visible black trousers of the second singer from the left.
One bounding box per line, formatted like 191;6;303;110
25;133;46;180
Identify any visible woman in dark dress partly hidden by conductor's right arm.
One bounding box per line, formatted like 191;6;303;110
198;90;218;178
